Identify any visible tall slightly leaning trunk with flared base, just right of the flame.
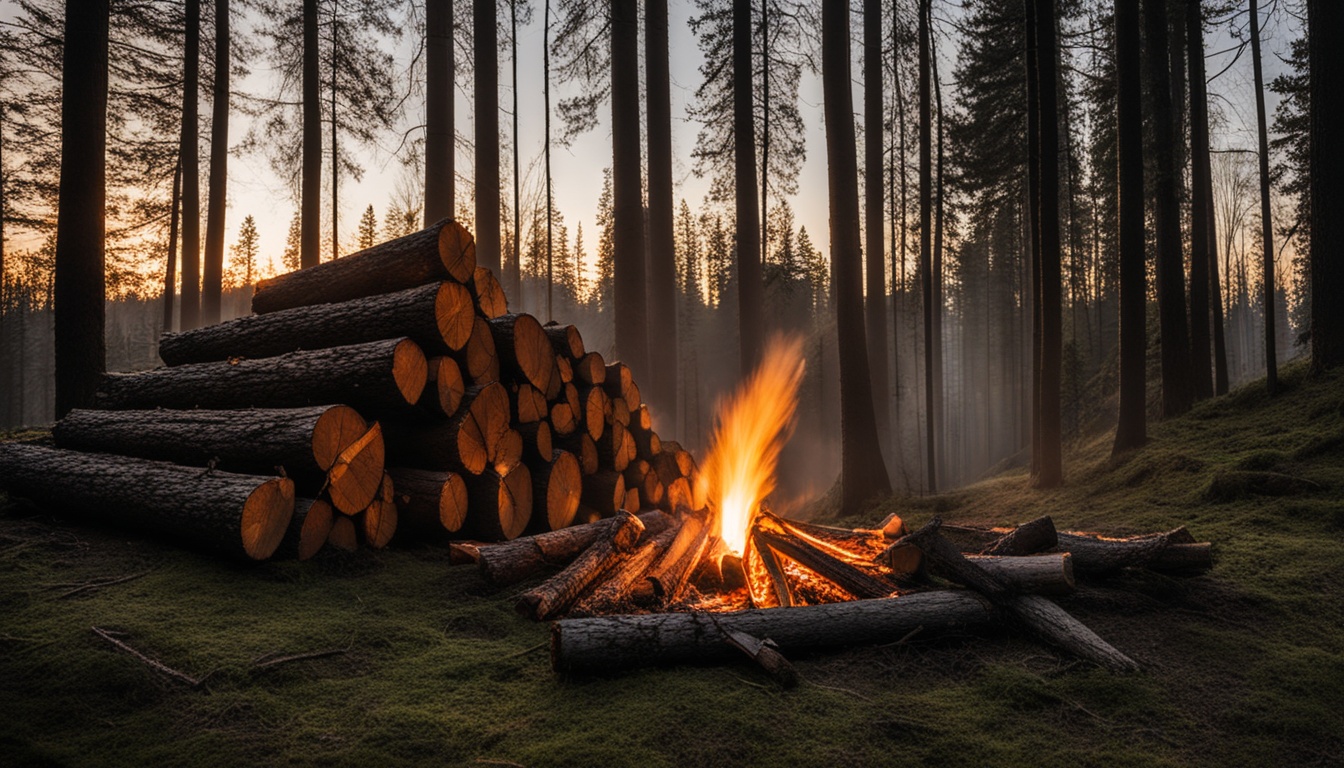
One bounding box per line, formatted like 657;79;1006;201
817;3;891;514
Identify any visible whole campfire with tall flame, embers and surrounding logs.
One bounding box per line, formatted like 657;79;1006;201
470;339;1211;685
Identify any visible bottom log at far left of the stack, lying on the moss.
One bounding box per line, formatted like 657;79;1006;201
0;443;294;560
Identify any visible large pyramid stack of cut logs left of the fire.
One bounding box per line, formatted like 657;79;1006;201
0;219;704;560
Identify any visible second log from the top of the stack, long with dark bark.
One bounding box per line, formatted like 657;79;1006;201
159;282;476;366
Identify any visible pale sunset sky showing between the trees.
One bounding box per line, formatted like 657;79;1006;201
0;0;1298;285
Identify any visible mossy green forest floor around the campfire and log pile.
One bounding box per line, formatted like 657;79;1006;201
0;364;1344;768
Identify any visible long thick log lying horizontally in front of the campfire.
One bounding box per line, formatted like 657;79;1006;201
551;590;996;675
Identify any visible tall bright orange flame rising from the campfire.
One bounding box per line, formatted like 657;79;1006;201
699;336;805;554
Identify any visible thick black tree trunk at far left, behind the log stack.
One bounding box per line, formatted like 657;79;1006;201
54;0;109;418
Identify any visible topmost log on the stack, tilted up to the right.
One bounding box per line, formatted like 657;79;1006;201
251;219;476;315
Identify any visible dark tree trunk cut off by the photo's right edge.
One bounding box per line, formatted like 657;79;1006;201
1306;0;1344;373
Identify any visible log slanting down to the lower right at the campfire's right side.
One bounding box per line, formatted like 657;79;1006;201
894;518;1138;671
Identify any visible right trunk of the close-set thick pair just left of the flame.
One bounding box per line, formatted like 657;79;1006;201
645;0;680;424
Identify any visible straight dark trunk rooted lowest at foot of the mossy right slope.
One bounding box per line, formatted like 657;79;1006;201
1028;0;1064;488
